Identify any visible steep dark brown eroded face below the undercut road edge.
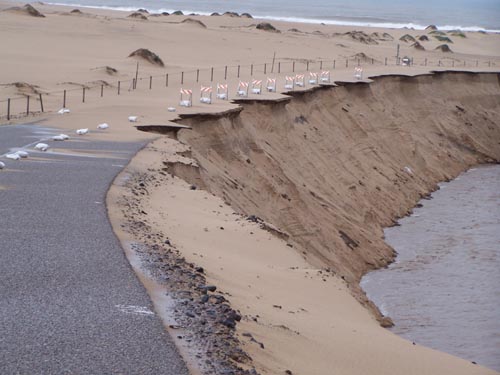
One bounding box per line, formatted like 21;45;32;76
172;73;500;284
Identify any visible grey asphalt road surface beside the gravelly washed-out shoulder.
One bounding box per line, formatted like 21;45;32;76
0;125;188;375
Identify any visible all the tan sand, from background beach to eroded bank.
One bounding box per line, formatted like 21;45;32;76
0;2;500;375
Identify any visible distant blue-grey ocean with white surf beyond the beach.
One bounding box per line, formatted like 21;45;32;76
44;0;500;32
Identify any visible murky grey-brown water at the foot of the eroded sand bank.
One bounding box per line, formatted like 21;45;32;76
361;166;500;371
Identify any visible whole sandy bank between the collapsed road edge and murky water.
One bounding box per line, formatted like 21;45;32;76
110;73;500;374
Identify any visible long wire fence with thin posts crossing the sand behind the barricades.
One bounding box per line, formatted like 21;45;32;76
0;56;500;121
